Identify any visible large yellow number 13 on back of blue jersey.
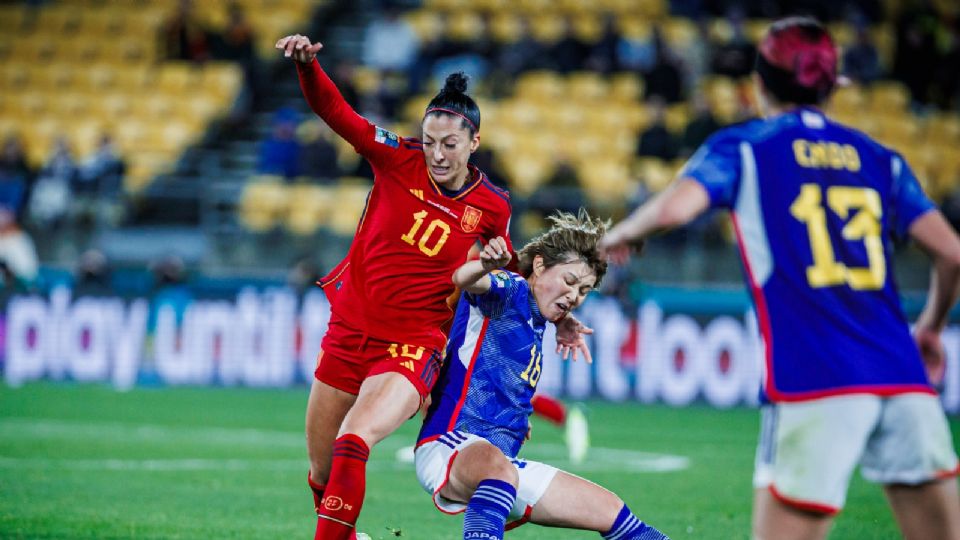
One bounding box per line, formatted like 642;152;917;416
790;184;887;290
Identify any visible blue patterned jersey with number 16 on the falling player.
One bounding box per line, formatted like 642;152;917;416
417;270;547;458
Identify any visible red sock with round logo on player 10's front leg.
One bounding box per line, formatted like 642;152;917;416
314;433;370;540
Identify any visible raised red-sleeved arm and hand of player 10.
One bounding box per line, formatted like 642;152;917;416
275;34;371;150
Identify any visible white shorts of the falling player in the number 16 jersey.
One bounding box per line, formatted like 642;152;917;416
414;431;558;529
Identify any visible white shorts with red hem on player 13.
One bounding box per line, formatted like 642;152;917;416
753;394;958;514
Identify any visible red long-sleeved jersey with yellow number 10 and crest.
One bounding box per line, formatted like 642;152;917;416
297;61;513;340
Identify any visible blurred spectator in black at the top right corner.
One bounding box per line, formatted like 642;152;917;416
893;0;940;106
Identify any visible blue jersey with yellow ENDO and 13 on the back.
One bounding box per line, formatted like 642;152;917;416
681;107;934;401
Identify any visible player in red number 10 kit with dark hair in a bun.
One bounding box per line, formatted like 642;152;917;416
276;34;589;540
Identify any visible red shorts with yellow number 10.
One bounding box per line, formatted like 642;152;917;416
313;314;446;400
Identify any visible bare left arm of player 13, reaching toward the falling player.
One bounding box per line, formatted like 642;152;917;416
600;178;710;264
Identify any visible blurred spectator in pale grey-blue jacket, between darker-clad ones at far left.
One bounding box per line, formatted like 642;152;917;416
28;137;80;227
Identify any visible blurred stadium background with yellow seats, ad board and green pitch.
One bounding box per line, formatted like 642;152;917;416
0;0;960;539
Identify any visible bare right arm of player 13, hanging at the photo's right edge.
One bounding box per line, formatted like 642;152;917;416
910;210;960;384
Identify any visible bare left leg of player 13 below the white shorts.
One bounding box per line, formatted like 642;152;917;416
753;489;833;540
